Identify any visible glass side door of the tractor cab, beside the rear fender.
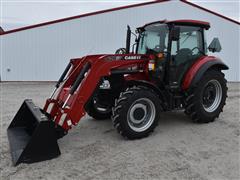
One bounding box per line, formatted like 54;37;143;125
169;26;205;88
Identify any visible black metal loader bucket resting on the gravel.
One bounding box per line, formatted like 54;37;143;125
7;100;61;165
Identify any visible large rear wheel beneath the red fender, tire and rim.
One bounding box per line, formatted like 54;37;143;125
185;70;227;123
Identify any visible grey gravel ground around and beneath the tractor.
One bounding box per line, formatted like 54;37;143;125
0;83;240;180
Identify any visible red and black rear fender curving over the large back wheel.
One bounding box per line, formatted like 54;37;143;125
182;56;229;91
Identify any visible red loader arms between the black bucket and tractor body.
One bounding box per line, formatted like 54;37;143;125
44;55;148;131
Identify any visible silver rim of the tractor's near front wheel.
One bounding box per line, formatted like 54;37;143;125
127;98;156;132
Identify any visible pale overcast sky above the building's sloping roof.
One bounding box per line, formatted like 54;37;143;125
0;0;240;31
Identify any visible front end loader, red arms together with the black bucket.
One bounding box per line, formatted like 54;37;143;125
7;55;150;165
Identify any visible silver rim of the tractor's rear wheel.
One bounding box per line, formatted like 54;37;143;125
202;80;222;113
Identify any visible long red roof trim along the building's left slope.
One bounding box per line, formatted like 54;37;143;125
0;0;170;36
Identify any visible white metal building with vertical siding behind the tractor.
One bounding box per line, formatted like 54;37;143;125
0;0;240;81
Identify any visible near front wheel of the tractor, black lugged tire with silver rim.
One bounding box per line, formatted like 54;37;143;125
112;86;162;139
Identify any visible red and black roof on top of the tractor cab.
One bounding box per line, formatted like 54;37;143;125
137;19;210;29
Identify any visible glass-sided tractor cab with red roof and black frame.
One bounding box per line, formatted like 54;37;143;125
127;20;221;88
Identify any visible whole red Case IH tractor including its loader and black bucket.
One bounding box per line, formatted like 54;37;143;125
8;20;228;165
